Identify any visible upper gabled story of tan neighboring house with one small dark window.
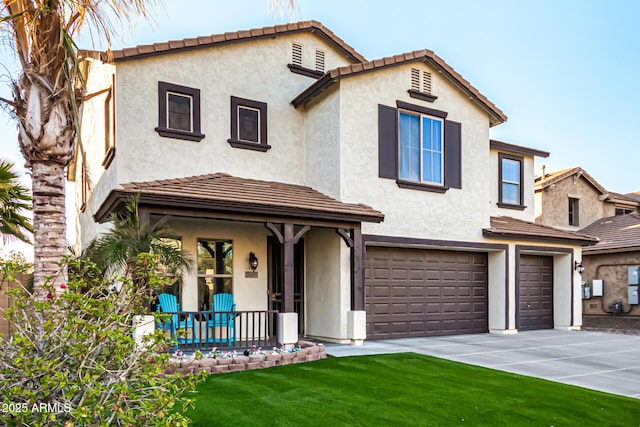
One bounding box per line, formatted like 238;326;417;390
535;167;640;231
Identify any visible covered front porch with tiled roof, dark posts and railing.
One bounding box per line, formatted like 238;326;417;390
95;174;383;349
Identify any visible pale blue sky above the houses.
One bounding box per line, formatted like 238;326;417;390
0;0;640;254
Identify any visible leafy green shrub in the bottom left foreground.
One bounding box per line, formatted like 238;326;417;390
0;255;202;426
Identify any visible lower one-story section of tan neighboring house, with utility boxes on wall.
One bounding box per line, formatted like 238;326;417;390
581;213;640;316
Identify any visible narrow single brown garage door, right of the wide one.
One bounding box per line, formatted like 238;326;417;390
518;255;553;331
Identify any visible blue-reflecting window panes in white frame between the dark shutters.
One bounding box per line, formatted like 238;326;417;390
399;111;444;185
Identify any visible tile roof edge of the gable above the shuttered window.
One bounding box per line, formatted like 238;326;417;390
291;49;507;126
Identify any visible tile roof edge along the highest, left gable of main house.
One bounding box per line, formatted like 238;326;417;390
112;21;365;62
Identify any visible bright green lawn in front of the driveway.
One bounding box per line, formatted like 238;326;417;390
188;353;640;427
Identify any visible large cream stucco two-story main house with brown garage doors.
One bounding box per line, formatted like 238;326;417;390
69;21;596;342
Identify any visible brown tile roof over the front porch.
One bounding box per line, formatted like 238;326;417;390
95;173;384;226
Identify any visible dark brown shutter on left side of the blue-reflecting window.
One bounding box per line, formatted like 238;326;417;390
378;104;398;179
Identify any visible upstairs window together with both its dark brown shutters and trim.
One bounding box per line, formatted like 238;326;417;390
378;101;462;193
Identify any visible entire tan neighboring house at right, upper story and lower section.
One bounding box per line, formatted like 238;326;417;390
534;167;640;316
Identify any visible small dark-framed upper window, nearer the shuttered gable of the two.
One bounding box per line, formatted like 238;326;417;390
227;96;271;151
